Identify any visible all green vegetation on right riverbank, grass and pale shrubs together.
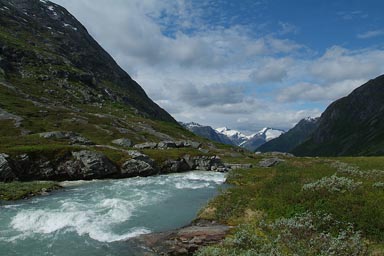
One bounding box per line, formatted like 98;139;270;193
198;157;384;256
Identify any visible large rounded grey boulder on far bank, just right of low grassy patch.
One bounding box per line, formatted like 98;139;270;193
69;150;118;179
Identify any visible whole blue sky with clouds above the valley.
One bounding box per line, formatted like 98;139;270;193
54;0;384;133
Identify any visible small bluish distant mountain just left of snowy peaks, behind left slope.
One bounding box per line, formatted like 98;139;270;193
180;122;232;146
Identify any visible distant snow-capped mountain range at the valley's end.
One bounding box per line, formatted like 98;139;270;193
181;122;284;151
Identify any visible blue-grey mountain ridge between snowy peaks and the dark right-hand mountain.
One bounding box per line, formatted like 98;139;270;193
256;117;319;152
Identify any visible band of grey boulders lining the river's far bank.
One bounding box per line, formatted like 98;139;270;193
0;138;251;182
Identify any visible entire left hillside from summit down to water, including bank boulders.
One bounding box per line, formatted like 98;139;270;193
0;0;231;181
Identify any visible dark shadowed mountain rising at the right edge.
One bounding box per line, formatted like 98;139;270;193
292;75;384;156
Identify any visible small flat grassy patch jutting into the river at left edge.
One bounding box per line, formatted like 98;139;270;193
0;181;60;201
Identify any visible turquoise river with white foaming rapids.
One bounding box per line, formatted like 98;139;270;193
0;171;225;256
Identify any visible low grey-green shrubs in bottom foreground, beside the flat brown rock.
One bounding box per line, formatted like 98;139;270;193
196;212;367;256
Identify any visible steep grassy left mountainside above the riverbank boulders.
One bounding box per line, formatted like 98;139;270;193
0;0;206;154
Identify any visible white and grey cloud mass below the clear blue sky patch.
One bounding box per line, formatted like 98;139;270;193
54;0;384;130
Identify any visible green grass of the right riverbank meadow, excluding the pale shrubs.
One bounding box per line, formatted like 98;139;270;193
199;157;384;255
